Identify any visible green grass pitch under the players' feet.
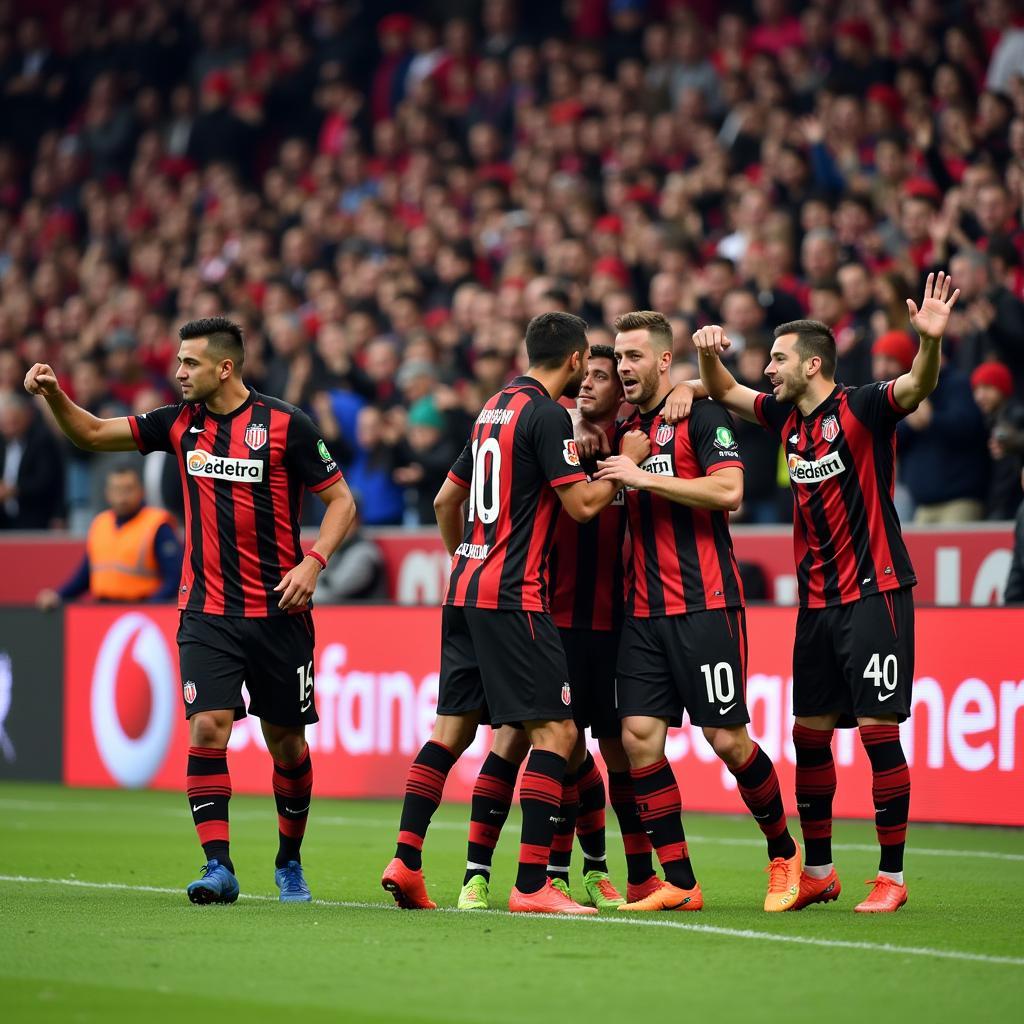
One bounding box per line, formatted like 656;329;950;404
0;784;1024;1024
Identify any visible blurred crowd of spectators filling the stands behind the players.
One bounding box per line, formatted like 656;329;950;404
0;0;1024;531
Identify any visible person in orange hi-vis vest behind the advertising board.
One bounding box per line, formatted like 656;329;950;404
36;463;181;610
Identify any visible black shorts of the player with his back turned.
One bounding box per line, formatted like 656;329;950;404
437;604;572;726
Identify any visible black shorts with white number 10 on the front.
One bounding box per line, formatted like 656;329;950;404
616;608;751;728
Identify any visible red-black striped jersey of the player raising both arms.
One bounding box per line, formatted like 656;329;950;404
754;381;918;608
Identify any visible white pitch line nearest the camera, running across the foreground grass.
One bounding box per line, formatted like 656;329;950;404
0;874;1024;967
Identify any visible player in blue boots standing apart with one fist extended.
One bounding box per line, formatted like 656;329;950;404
25;316;354;903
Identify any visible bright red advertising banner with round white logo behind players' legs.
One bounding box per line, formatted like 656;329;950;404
63;606;1024;825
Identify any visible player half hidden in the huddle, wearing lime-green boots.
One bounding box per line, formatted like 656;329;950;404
459;345;654;910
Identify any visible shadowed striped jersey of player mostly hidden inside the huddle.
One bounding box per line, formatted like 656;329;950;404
550;426;626;632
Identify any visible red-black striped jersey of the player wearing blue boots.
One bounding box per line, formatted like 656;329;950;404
128;389;341;618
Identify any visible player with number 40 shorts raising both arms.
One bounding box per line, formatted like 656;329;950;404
693;272;959;913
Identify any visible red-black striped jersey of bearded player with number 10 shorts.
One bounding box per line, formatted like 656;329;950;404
622;401;743;618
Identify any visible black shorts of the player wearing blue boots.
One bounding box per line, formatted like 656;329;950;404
178;611;318;725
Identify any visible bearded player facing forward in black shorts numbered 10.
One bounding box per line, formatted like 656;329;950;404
597;311;801;911
